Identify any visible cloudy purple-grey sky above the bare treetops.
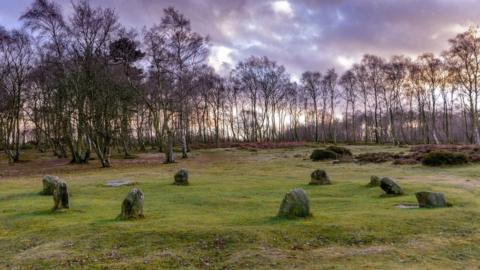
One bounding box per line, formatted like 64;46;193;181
0;0;480;78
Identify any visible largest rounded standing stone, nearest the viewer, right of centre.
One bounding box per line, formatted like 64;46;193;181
278;188;310;217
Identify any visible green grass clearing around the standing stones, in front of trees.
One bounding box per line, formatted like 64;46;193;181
0;146;480;269
